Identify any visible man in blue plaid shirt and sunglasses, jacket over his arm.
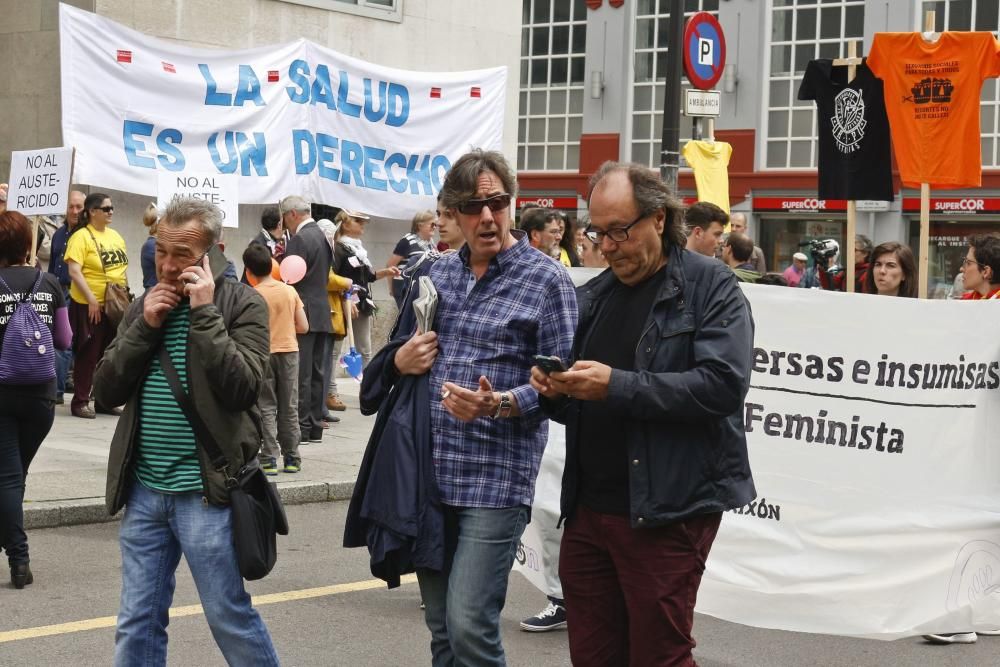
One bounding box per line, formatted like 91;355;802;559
395;150;577;665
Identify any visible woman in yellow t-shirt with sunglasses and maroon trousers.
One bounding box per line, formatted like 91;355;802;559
64;192;128;419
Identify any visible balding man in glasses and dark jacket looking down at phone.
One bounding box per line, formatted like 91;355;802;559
532;162;755;666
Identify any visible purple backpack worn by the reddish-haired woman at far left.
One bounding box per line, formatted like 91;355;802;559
0;271;56;384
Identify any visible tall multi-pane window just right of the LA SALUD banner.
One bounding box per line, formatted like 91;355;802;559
517;0;587;171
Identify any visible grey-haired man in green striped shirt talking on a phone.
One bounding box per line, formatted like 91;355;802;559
94;198;278;665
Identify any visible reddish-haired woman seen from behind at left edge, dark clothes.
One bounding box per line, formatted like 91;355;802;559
0;211;72;588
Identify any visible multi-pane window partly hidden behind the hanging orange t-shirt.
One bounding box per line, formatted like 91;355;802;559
916;0;1000;167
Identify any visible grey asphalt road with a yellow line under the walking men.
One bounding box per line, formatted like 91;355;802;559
0;503;1000;667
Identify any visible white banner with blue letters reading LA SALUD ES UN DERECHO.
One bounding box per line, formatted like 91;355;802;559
59;4;507;218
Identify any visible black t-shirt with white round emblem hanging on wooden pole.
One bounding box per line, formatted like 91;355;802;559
799;58;892;201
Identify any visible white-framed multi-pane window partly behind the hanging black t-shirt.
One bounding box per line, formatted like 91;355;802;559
762;0;868;169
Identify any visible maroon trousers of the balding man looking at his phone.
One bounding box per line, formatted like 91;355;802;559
559;506;722;667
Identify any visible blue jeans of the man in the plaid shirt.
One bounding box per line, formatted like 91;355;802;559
417;505;530;667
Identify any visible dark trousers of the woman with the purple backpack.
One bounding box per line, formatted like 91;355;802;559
0;391;55;565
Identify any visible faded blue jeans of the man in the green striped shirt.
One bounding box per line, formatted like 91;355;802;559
115;481;278;666
